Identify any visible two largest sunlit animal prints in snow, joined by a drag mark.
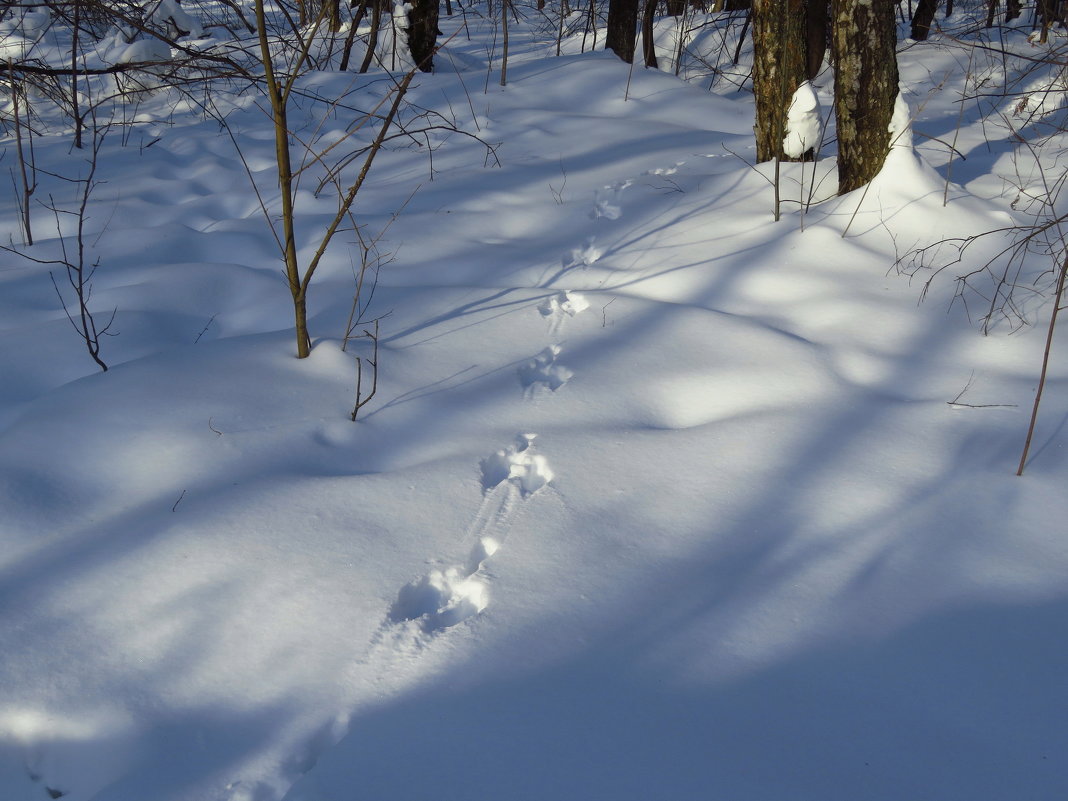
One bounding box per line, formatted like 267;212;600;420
389;434;552;633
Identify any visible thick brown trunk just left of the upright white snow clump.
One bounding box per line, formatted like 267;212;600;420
752;0;808;161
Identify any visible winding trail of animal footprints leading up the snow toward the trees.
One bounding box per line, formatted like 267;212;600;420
388;164;679;633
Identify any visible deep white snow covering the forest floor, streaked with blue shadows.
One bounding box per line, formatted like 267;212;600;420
0;6;1068;801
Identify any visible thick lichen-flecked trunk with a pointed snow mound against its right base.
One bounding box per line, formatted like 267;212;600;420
831;0;898;194
